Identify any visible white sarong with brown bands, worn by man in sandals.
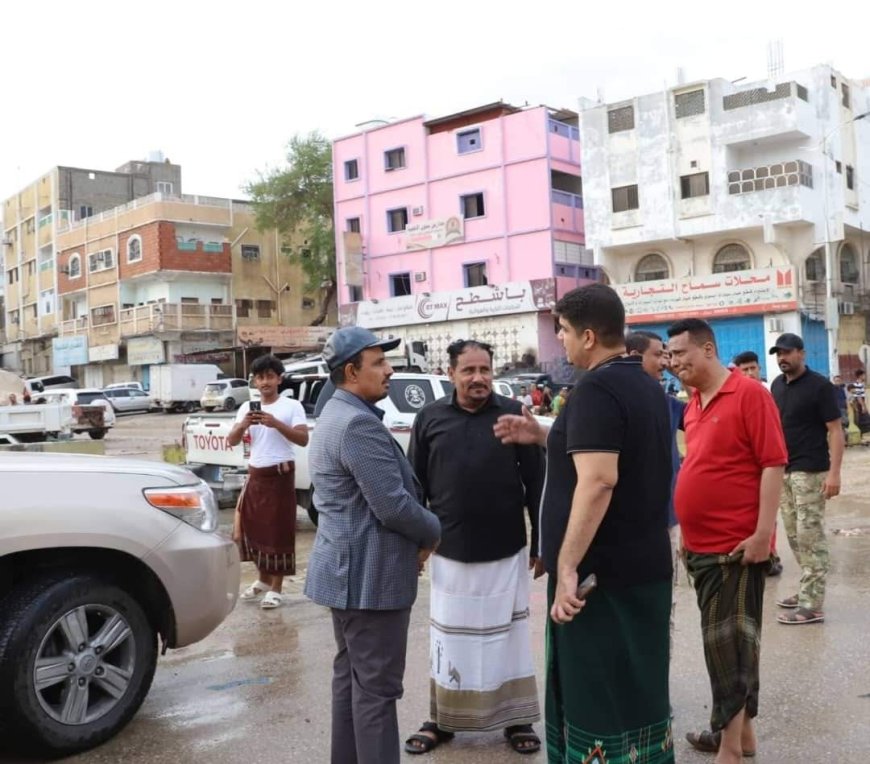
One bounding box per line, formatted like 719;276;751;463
429;549;541;732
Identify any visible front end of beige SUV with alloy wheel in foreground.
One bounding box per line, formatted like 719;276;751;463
0;453;239;757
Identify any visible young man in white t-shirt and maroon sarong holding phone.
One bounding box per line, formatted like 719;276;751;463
227;355;308;610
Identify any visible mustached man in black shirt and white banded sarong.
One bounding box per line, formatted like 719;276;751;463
405;340;544;753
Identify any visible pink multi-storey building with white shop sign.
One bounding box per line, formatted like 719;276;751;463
333;103;596;374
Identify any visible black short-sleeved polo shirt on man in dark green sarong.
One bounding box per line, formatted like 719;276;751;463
541;356;673;588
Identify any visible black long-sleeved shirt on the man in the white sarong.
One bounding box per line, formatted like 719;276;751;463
408;393;544;562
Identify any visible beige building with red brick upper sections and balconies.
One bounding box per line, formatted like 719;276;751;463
54;193;335;386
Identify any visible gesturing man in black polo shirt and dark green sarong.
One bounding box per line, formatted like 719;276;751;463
495;284;673;762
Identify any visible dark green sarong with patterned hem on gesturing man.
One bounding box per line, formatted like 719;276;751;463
546;576;674;764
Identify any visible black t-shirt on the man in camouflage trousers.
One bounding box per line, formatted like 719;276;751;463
770;367;840;472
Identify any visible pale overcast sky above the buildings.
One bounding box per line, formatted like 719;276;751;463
0;0;870;209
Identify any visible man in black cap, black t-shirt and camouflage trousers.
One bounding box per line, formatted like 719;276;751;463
770;333;846;625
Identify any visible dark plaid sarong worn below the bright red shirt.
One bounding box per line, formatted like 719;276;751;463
686;551;770;732
